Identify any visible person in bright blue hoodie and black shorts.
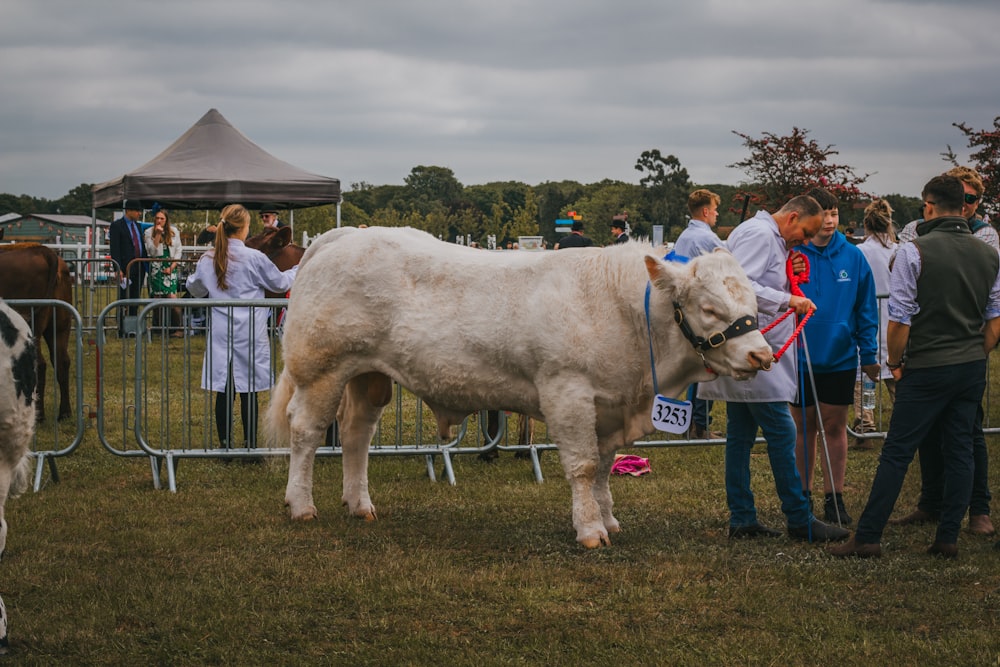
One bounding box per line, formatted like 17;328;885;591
791;188;879;525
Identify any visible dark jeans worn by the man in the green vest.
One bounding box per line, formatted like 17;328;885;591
855;360;986;544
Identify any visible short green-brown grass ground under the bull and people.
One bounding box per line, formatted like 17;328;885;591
0;310;1000;667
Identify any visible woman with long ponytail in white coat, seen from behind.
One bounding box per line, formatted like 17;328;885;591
187;204;298;448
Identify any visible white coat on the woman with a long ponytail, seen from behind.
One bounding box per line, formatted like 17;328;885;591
187;238;298;393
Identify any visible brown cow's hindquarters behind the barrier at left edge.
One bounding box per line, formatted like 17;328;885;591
0;243;73;422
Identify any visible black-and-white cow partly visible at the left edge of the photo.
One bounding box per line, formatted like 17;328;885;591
0;299;37;556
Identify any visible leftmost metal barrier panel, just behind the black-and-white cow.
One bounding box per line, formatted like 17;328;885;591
7;299;89;491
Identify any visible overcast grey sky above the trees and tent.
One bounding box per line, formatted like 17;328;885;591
0;0;1000;199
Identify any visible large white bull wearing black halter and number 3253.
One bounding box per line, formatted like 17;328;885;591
266;228;773;547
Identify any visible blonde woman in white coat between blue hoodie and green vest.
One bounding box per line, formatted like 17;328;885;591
854;199;899;449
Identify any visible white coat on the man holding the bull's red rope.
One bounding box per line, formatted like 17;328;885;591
698;211;798;403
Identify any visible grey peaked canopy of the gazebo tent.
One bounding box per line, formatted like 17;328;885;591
94;109;340;209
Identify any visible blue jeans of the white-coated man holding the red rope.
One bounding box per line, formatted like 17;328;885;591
726;401;812;528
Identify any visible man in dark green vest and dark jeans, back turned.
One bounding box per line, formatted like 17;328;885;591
829;175;1000;558
